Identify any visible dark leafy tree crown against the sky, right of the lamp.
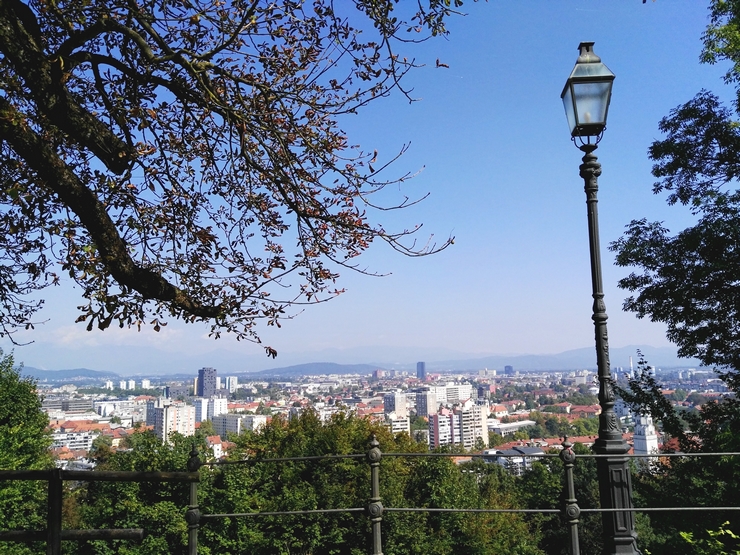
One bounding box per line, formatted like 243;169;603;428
611;0;740;369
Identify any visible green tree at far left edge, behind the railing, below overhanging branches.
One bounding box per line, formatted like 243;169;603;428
0;350;53;555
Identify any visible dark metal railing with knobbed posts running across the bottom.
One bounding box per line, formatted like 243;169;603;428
0;437;740;555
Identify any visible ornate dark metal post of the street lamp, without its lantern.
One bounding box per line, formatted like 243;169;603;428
580;143;640;555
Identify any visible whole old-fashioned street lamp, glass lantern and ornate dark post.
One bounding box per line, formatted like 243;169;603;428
560;42;640;555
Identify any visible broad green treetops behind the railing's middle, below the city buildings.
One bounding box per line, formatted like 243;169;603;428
73;411;542;555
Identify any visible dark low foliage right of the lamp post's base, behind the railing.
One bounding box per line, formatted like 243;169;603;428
618;355;740;555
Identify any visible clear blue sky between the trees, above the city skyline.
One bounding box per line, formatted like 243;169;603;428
1;0;732;373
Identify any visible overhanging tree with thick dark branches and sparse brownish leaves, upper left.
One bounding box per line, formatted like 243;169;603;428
0;0;454;355
